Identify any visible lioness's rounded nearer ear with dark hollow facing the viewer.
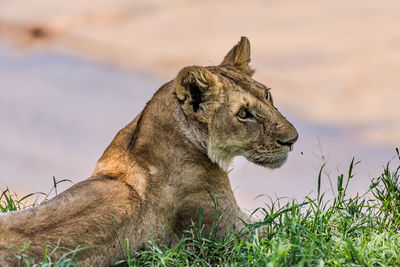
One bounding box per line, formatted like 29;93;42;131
174;66;220;112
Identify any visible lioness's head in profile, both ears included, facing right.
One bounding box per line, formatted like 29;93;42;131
174;37;298;170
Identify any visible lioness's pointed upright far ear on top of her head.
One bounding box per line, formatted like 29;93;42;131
220;36;254;76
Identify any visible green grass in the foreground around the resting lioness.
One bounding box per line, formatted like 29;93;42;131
0;149;400;266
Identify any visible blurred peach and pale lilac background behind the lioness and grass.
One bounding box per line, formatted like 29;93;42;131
0;0;400;213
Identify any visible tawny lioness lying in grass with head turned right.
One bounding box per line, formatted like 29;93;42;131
0;37;298;266
